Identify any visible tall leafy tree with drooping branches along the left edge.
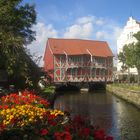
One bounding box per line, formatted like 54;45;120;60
0;0;39;88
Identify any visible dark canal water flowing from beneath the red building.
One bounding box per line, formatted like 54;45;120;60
54;92;140;140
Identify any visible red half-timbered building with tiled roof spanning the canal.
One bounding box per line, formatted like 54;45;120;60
44;38;113;83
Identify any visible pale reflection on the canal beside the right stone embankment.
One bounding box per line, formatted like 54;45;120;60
113;98;140;140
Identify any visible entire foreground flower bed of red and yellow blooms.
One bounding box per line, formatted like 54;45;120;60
0;92;113;140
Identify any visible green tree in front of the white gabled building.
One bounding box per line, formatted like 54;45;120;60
118;31;140;85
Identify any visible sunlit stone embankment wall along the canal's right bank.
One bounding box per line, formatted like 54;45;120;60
106;85;140;109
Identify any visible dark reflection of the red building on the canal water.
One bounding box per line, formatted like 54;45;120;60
54;93;112;132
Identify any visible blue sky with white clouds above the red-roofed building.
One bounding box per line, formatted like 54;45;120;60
23;0;140;66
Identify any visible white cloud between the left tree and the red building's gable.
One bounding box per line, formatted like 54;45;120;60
27;22;58;66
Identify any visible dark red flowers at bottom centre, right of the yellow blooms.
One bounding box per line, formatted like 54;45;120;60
60;116;113;140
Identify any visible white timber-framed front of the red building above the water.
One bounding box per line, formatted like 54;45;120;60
54;53;111;82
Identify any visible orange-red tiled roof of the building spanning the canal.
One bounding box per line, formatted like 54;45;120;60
48;38;113;57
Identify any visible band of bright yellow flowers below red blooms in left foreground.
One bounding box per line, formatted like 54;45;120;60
0;105;64;129
